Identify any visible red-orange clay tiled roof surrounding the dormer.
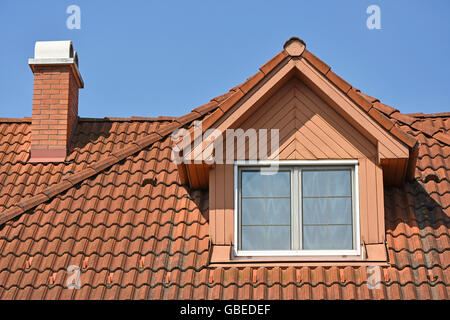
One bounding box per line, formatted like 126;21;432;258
0;40;450;299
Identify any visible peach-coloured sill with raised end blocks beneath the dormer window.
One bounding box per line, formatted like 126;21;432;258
210;243;388;267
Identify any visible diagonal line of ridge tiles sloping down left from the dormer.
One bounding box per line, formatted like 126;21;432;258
0;110;213;225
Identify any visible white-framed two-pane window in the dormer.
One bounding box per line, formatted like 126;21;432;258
235;160;359;256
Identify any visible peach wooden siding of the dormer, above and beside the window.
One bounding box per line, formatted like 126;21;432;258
209;78;385;245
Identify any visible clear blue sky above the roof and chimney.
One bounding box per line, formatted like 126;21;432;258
0;0;450;117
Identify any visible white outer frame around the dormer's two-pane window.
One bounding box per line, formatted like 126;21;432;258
233;160;361;257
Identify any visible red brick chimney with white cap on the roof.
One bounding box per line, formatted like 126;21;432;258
28;41;84;162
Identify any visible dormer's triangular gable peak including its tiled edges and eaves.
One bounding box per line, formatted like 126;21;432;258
180;38;417;188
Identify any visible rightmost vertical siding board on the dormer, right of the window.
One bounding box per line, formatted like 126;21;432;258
368;159;378;243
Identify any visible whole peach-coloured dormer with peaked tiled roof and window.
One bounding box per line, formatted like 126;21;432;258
174;38;418;265
